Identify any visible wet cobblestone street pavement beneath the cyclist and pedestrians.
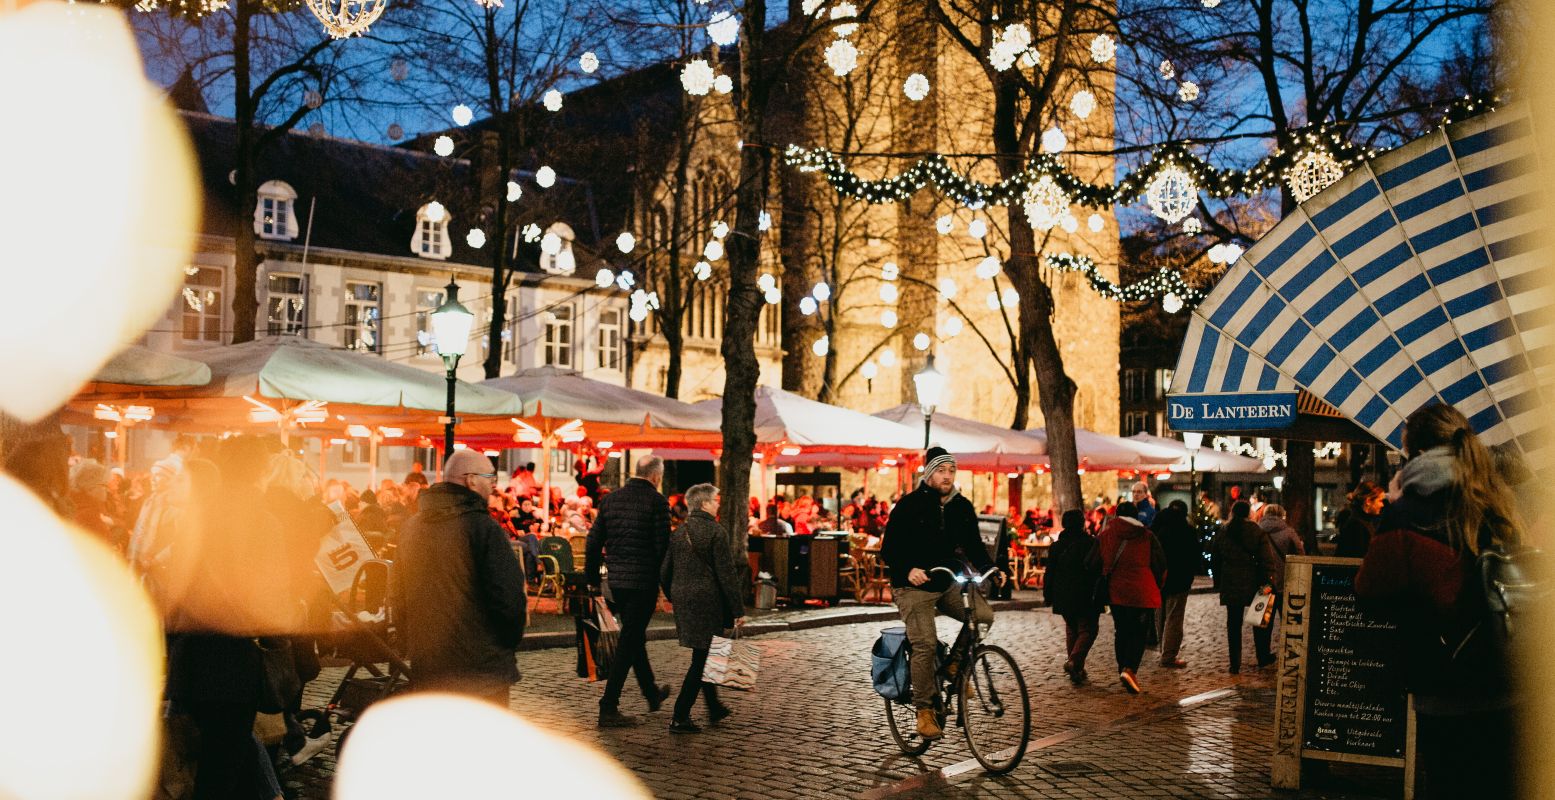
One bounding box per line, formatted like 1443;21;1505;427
283;595;1398;800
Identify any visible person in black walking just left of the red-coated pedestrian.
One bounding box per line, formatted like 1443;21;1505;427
1042;509;1101;686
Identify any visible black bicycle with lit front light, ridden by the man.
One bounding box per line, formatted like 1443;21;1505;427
885;567;1031;775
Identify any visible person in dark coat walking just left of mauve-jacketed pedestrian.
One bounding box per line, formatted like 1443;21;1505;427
1210;500;1280;675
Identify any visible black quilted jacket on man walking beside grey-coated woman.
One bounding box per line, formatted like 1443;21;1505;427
583;478;670;590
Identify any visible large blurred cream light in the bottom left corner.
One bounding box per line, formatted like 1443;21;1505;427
0;473;163;798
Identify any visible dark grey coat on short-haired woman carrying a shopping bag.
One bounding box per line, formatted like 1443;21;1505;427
659;511;745;649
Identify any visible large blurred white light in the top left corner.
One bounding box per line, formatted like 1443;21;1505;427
0;3;197;423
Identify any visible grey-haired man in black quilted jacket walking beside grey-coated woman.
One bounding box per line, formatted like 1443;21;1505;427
583;456;670;728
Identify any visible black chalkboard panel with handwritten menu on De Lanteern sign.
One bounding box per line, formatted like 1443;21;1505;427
1302;563;1409;758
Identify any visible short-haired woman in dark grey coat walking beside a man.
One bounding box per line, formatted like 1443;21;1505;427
659;484;745;733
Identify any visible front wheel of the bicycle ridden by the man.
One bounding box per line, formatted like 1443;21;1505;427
961;644;1031;775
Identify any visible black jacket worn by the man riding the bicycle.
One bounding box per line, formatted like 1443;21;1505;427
880;482;994;591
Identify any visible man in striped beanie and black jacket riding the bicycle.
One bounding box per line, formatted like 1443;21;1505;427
880;447;1005;739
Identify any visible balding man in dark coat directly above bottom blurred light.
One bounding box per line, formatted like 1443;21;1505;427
395;450;527;708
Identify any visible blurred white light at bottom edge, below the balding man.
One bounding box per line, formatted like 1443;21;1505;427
337;694;652;800
